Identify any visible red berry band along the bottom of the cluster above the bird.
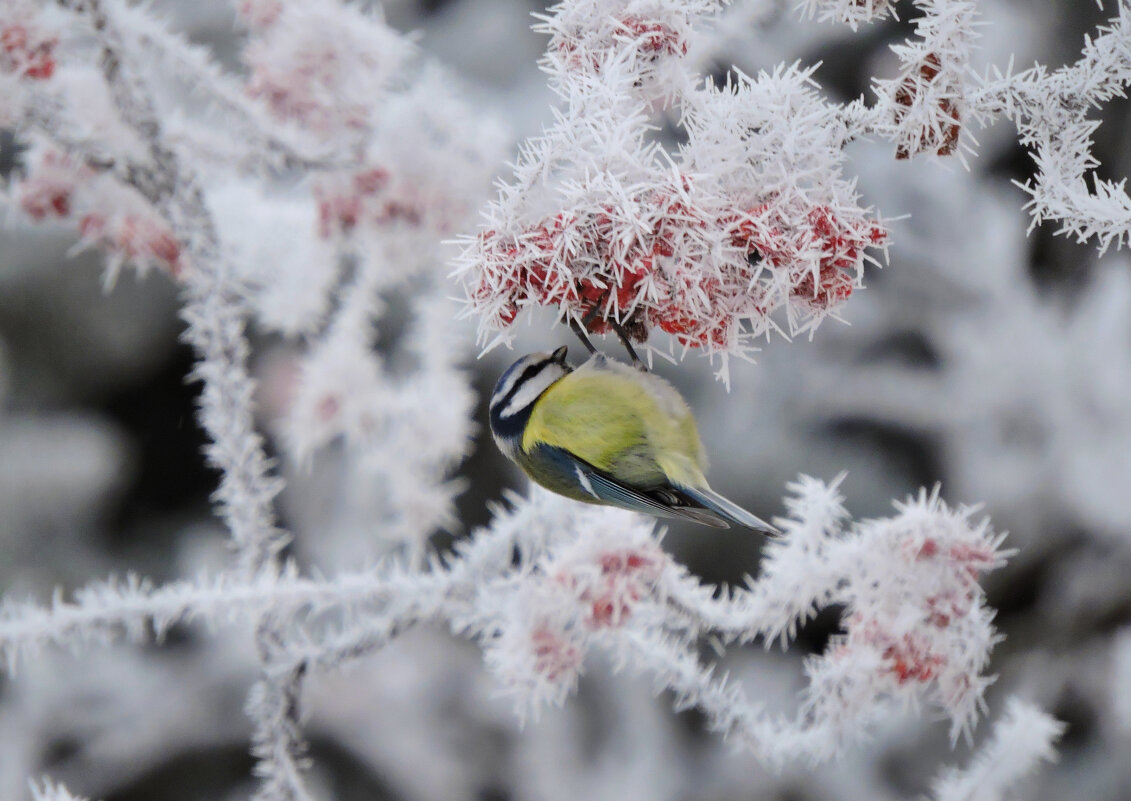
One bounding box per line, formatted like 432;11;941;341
473;186;887;348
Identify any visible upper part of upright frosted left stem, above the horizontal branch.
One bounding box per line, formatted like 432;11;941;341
59;0;286;575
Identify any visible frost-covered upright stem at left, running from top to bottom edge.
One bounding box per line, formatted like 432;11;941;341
48;6;305;799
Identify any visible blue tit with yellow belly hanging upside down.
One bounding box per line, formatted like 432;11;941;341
490;346;779;534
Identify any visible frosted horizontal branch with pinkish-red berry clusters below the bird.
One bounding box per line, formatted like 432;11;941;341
0;477;1022;764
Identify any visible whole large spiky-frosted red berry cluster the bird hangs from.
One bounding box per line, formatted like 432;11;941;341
458;0;887;359
